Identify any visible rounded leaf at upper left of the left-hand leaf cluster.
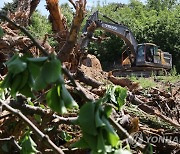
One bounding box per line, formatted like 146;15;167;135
6;57;27;75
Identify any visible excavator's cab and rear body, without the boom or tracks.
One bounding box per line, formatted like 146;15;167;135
122;43;172;69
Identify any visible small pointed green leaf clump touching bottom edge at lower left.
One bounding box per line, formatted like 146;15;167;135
20;133;38;154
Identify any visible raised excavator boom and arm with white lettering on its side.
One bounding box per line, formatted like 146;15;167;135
81;11;138;64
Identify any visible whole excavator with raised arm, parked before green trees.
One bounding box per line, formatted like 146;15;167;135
81;11;172;76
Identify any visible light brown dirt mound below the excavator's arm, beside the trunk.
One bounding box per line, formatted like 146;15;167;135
81;54;107;80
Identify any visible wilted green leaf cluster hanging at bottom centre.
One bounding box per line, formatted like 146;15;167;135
73;86;127;154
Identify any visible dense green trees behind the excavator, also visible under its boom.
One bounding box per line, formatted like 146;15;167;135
85;0;180;72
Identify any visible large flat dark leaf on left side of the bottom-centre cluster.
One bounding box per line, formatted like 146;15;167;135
78;102;97;135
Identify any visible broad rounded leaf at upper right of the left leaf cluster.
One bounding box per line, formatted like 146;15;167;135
42;59;61;83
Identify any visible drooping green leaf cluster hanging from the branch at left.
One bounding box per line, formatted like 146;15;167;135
1;54;78;114
